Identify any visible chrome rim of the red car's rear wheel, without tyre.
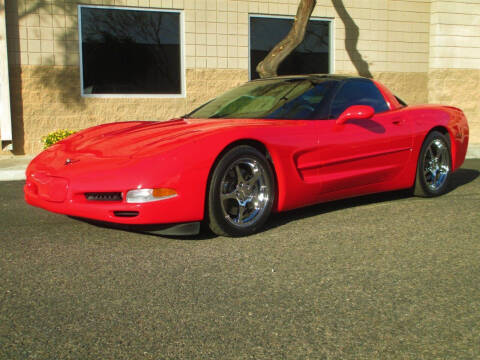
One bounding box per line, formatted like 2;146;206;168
423;138;450;191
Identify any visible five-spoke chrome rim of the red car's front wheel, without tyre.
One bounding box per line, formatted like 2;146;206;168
220;157;271;227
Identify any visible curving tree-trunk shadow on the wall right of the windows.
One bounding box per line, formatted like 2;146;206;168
332;0;373;79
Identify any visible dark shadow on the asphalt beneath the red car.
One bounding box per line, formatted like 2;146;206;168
71;168;480;241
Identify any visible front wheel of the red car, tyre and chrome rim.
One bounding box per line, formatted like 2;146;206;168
207;145;275;236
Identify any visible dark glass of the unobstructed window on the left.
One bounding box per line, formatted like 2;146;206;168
80;7;182;94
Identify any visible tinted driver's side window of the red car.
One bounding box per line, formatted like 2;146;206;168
330;79;389;119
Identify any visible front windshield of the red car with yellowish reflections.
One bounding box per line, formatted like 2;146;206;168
187;79;333;119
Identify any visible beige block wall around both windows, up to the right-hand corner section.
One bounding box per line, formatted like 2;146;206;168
0;0;480;153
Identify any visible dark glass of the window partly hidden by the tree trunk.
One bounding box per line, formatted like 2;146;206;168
250;16;330;80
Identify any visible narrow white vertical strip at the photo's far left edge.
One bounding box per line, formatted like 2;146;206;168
0;0;12;145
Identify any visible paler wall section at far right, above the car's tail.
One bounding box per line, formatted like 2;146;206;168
428;0;480;144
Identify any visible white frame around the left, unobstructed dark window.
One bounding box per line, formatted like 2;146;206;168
77;5;186;99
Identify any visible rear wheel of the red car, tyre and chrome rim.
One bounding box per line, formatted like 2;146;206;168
414;131;452;197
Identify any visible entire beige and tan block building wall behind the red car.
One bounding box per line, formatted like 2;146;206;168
0;0;480;154
